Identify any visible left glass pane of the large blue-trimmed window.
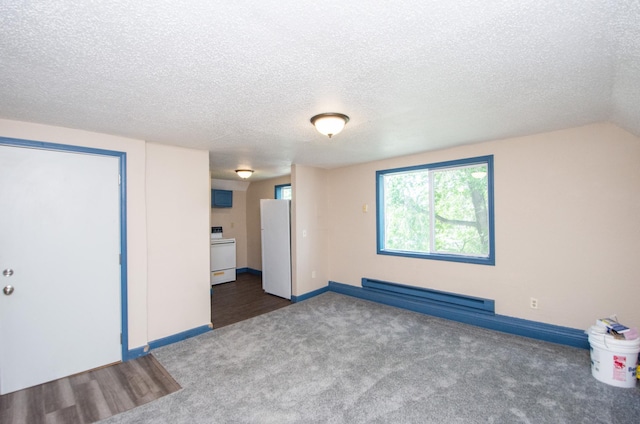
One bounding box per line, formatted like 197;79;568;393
384;170;430;252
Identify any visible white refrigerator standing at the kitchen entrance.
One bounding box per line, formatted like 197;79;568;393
260;199;291;299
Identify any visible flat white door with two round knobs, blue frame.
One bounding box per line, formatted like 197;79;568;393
0;145;122;394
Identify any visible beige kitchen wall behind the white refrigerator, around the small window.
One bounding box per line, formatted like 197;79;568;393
246;175;291;270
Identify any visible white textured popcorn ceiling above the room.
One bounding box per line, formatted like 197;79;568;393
0;0;640;179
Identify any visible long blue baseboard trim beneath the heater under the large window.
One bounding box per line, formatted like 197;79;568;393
328;281;589;349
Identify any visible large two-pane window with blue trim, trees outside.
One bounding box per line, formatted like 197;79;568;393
376;155;495;265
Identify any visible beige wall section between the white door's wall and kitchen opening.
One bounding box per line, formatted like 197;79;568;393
146;143;211;340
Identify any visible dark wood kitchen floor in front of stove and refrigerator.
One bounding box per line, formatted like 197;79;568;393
211;272;291;329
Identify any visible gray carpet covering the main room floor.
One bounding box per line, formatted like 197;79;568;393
104;293;640;423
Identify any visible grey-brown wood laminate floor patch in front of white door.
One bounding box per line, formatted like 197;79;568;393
0;355;180;424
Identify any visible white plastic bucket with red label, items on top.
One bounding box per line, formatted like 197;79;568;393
588;326;640;387
